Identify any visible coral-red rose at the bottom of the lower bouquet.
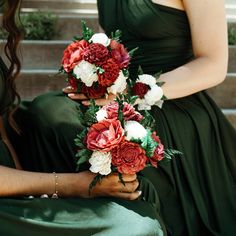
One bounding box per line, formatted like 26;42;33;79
111;141;147;175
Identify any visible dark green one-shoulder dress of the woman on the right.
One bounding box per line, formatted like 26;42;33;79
9;0;236;236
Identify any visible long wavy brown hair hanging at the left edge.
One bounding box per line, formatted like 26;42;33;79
1;0;21;130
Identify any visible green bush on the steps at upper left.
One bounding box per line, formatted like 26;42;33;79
0;12;57;40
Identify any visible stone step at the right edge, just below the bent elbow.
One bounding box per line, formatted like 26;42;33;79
207;73;236;108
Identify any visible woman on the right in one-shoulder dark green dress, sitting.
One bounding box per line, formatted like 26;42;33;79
21;0;236;236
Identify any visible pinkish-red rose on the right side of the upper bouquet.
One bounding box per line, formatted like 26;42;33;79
110;40;130;69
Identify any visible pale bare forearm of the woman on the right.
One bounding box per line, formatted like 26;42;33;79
160;55;227;99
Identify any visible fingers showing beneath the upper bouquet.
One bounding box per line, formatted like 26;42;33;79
63;86;116;106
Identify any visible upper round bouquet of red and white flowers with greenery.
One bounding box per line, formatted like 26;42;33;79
60;22;132;99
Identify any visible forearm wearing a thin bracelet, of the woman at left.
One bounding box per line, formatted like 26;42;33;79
0;166;89;197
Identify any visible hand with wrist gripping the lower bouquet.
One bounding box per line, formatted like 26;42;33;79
78;171;141;200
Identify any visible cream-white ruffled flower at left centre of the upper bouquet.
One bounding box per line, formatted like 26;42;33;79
73;60;98;87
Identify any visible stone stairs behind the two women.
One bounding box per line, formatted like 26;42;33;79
7;0;236;127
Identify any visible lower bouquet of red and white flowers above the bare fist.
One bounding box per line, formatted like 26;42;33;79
75;95;180;193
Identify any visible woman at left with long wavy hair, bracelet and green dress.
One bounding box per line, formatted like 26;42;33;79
0;0;164;236
